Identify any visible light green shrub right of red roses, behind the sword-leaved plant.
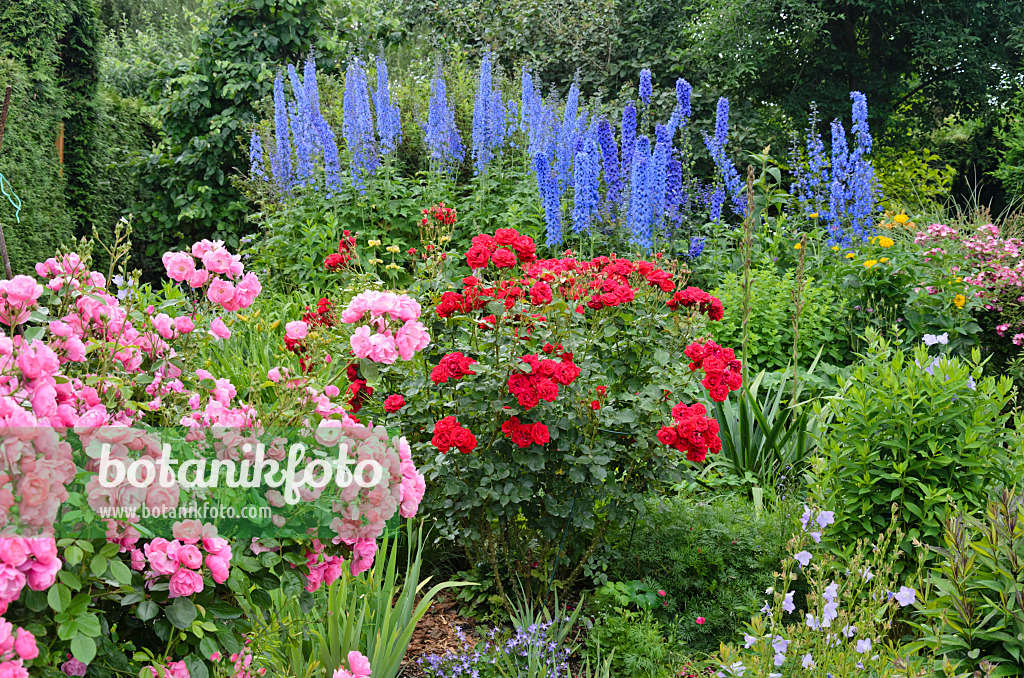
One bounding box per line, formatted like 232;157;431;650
711;269;850;372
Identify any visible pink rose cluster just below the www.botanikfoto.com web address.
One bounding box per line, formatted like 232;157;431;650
131;520;231;598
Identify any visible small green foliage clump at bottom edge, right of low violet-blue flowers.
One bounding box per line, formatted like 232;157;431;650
587;609;678;678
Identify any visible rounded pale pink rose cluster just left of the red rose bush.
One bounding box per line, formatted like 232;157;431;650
341;291;430;365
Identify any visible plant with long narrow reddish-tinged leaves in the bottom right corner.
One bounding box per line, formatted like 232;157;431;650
908;490;1024;676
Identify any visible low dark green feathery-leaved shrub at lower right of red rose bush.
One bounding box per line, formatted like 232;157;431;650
602;496;792;656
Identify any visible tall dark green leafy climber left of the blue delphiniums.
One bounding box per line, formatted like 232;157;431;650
138;0;319;256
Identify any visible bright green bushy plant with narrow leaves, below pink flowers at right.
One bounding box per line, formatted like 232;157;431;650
815;332;1020;565
